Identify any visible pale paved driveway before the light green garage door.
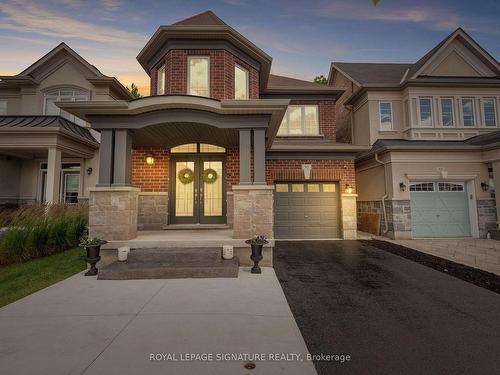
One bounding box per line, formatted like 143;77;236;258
381;238;500;275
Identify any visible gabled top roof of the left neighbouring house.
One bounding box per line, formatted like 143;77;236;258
0;42;132;99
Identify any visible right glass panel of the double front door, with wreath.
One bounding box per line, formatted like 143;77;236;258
203;161;224;217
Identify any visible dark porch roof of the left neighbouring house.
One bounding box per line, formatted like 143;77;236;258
0;116;98;144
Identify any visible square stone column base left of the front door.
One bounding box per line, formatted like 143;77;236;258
89;186;141;240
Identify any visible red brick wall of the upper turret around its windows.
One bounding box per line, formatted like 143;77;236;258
150;50;259;99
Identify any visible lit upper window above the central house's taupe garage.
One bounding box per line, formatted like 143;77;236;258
278;105;319;136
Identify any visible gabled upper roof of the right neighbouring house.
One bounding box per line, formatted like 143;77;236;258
329;28;500;88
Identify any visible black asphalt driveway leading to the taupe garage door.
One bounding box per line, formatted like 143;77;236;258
274;241;500;375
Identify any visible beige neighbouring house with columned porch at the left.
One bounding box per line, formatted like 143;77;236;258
0;43;131;204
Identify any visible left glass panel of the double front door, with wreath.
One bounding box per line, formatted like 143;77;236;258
175;161;196;218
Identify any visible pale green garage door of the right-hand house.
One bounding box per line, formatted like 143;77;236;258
410;182;471;237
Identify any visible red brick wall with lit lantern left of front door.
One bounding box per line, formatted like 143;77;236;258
132;148;170;192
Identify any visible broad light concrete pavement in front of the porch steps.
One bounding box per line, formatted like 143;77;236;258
0;268;316;375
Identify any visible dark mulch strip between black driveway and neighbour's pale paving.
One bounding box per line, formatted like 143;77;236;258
361;239;500;294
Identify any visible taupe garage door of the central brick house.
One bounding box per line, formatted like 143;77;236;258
274;182;340;239
